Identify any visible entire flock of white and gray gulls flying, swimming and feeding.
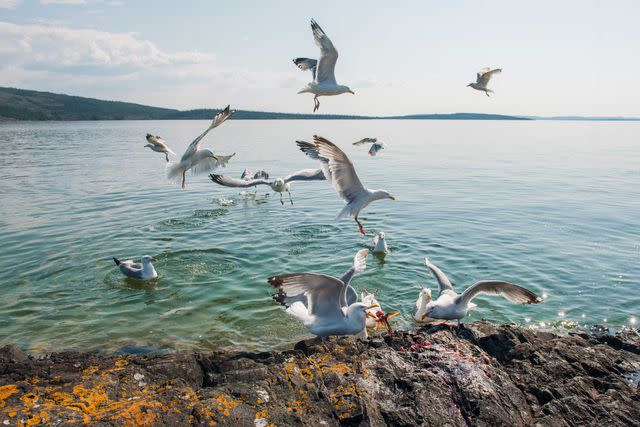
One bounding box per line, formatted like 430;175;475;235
119;19;542;340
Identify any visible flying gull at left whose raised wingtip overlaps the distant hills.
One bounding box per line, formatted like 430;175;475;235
167;105;235;188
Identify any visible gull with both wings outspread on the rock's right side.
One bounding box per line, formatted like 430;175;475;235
422;257;542;326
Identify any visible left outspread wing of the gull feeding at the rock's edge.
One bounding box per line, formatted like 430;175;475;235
268;273;346;317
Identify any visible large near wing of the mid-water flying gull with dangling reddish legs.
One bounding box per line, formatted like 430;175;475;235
308;135;366;203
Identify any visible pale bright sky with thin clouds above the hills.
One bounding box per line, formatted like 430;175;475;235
0;0;640;116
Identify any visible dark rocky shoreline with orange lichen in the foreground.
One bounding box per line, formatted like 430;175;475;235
0;321;640;427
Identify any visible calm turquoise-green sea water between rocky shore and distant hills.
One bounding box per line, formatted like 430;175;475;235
0;121;640;352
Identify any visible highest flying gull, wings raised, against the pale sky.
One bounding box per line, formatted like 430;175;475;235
293;19;355;113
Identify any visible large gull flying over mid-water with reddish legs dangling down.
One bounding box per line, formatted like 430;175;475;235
296;135;395;235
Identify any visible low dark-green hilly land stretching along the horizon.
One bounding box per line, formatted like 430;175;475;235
0;87;640;121
